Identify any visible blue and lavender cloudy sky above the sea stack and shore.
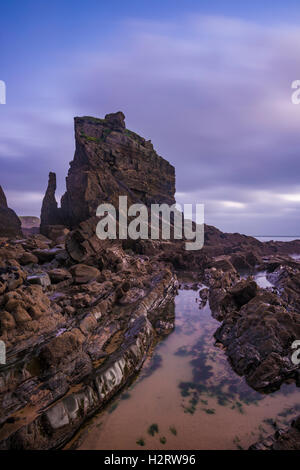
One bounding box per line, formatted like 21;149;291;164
0;0;300;236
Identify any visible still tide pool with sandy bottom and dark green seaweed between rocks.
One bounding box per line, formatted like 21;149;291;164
77;290;300;450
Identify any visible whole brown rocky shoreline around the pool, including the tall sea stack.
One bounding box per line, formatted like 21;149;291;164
0;112;300;449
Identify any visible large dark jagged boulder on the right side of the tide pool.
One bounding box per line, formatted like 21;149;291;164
215;290;300;391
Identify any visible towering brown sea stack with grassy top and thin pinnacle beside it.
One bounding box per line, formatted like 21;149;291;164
41;112;175;228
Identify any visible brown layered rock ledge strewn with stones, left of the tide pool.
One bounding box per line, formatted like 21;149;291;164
0;236;177;449
